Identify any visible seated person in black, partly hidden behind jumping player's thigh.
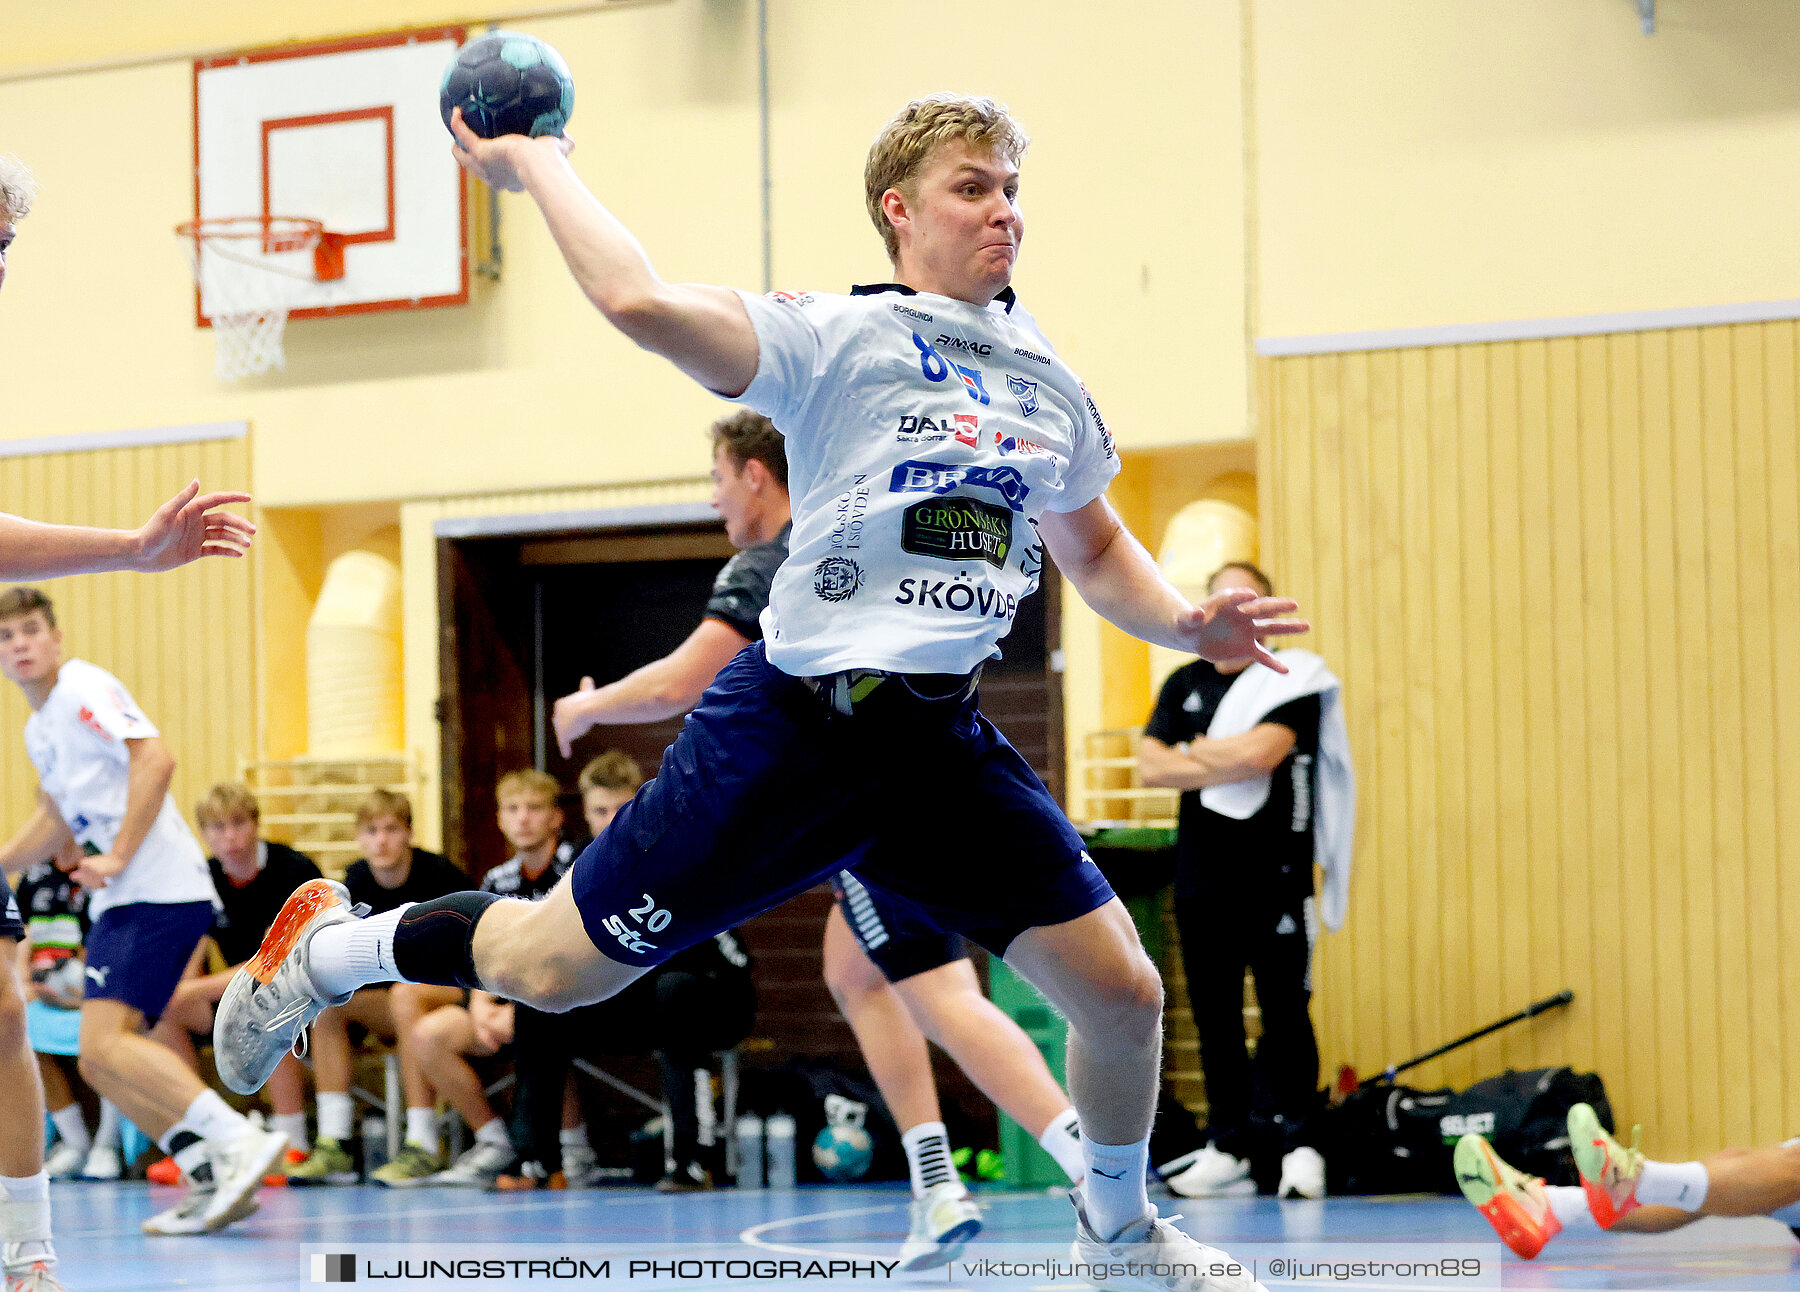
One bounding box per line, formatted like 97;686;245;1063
495;749;756;1193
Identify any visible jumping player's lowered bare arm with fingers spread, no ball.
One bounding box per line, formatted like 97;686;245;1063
1037;497;1312;673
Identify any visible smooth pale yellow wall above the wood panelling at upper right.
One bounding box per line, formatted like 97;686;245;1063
1249;0;1800;336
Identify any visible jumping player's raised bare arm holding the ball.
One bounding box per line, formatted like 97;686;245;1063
450;108;756;398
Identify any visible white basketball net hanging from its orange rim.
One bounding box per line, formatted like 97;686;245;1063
175;216;344;381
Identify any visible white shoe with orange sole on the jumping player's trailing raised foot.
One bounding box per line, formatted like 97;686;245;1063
212;880;356;1094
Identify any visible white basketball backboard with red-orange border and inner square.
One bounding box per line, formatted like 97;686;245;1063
194;27;468;324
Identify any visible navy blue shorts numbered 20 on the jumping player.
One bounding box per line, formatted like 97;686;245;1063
571;642;1112;966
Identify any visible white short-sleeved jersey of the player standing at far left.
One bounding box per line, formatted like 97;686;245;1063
25;659;218;920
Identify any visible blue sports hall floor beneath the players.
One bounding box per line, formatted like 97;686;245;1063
38;1182;1800;1292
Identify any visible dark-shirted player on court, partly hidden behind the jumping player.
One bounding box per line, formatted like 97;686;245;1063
553;417;1082;1269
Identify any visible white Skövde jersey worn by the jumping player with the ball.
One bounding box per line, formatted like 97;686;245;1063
740;284;1120;677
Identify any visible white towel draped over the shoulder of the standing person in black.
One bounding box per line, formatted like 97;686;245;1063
1201;650;1355;932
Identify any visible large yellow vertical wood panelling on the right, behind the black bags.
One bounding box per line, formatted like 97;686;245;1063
1262;322;1800;1159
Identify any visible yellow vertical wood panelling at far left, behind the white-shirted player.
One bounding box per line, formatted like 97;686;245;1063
0;439;257;833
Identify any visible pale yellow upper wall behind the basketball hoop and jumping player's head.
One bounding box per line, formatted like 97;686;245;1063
0;0;1247;507
